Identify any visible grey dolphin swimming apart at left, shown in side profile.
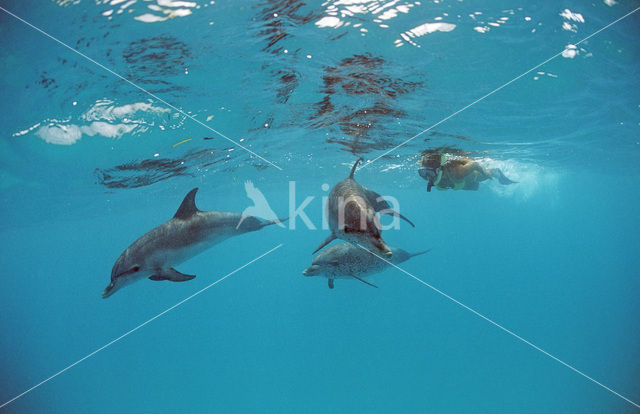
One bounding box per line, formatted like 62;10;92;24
102;188;287;298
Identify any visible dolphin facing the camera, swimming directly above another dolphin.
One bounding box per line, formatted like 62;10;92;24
313;157;415;257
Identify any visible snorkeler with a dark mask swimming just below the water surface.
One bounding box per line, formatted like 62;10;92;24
418;149;515;191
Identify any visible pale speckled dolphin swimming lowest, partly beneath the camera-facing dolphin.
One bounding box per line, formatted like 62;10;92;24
302;243;431;289
